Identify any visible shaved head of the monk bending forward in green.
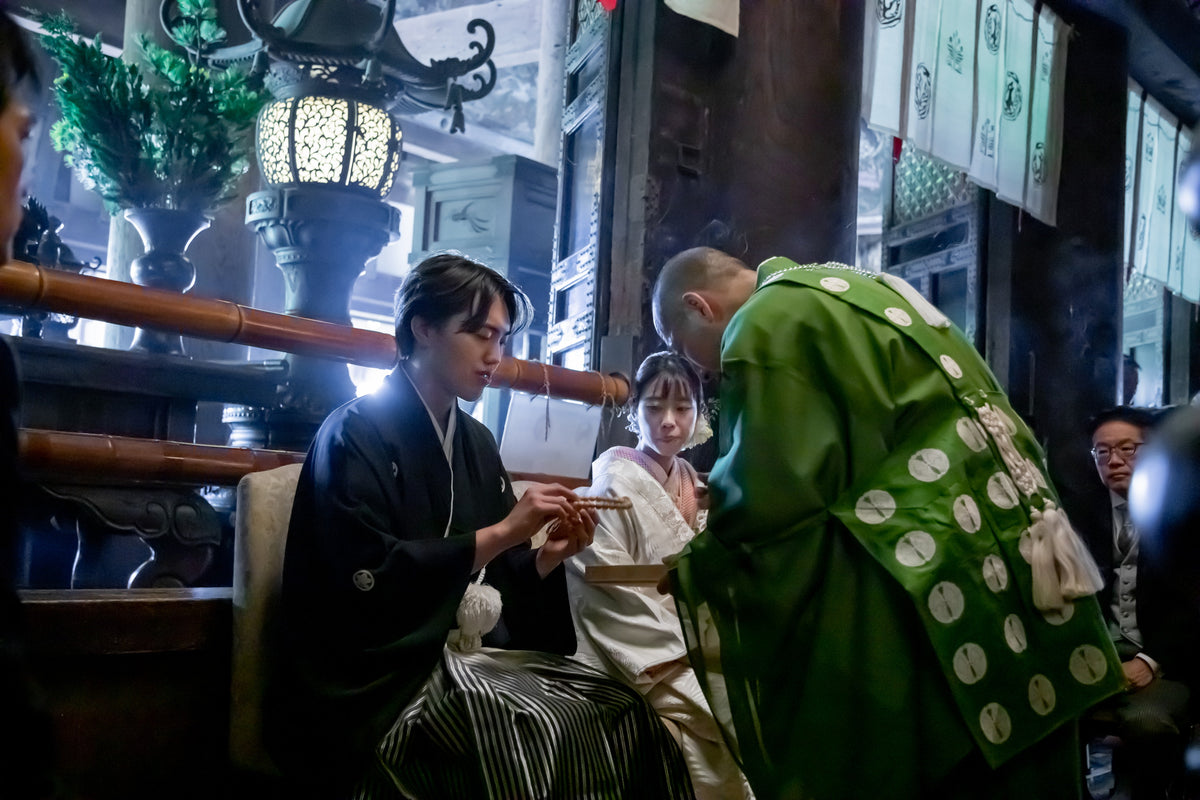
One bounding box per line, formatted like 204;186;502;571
653;247;757;373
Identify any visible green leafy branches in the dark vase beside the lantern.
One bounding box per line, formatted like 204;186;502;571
40;0;269;213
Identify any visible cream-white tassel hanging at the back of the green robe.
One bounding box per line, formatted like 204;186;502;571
1030;503;1104;610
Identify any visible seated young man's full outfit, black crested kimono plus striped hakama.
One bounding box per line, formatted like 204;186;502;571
265;371;691;800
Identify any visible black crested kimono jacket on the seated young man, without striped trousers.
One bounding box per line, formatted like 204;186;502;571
266;371;575;796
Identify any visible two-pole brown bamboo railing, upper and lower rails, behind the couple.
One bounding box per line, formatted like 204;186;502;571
0;261;629;486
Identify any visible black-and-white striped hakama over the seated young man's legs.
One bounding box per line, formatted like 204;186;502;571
355;648;692;800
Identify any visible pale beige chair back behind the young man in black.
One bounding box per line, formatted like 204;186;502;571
229;464;301;776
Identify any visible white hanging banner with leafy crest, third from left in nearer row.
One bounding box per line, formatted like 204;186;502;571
929;0;978;172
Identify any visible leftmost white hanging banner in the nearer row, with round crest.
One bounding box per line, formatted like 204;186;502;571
863;0;912;137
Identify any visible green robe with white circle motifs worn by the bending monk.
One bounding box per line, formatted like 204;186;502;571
672;258;1122;800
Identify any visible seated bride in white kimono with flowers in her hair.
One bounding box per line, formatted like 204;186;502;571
566;351;752;800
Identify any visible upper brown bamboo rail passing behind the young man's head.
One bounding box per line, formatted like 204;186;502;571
0;261;629;407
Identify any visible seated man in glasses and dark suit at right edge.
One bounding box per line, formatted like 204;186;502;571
1081;405;1200;798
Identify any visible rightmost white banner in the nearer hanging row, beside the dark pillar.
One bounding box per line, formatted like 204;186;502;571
1024;6;1069;225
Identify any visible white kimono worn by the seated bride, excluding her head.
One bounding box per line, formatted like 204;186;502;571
566;447;752;800
